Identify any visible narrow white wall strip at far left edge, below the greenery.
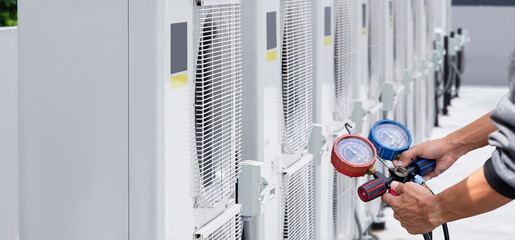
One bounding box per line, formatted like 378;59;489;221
0;28;18;240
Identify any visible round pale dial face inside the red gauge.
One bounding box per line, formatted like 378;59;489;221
336;137;375;165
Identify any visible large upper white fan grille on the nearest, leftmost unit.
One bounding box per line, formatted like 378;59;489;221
195;4;241;207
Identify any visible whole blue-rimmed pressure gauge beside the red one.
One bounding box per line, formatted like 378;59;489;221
368;120;411;161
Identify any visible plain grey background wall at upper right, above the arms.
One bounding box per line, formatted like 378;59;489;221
452;6;515;86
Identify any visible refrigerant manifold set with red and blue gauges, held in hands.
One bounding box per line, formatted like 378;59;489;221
331;120;436;202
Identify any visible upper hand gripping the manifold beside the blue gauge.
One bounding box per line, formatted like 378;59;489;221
393;138;460;180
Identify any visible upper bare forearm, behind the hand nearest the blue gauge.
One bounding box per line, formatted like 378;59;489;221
443;112;497;157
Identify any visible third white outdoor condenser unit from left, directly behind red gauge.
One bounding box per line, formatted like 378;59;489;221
310;0;361;239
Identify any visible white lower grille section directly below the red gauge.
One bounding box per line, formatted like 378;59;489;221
333;170;355;239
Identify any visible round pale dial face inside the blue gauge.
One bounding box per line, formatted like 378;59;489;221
374;123;410;149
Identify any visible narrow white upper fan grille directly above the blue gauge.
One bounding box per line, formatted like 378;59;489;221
368;0;385;101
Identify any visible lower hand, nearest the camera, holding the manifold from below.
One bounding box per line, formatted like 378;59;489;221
381;181;441;234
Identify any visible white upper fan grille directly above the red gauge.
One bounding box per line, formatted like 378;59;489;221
334;0;358;121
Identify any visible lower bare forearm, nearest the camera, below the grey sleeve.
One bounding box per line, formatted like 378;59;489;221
426;167;512;226
